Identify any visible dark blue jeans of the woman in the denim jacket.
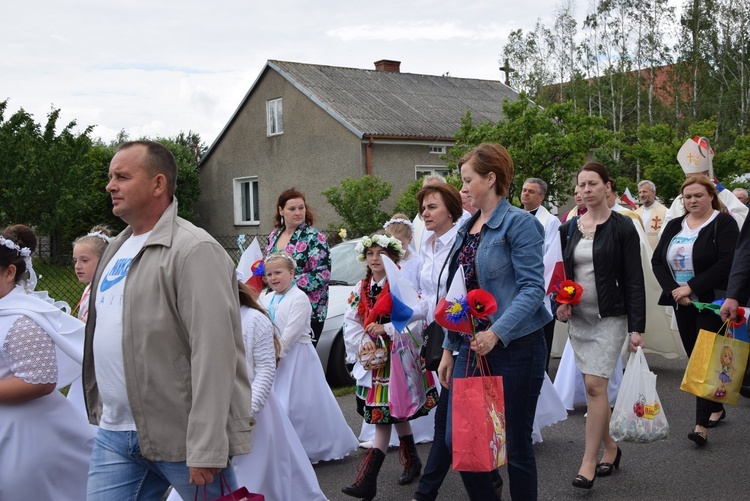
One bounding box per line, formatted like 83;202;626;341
446;329;547;501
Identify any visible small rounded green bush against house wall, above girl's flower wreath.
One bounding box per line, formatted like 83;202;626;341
322;175;392;238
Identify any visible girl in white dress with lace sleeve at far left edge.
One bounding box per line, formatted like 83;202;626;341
0;225;94;501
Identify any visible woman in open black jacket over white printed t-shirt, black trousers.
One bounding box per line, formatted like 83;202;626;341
651;176;739;445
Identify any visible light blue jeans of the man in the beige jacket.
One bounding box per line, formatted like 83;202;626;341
86;428;237;501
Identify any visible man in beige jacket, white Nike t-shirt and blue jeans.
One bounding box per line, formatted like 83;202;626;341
83;141;254;501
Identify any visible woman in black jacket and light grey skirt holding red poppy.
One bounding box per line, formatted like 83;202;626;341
556;162;646;489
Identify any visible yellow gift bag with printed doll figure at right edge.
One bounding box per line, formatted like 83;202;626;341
680;322;750;405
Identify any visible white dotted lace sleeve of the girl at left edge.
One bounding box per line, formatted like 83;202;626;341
3;316;57;384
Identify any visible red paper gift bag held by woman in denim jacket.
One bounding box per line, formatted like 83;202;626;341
451;368;507;472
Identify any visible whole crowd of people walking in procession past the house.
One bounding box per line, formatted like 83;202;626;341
0;139;750;501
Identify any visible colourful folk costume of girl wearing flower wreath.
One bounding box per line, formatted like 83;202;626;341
344;279;439;424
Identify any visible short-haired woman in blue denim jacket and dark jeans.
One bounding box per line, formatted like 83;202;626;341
438;143;552;501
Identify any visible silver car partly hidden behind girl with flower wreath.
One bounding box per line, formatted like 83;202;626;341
315;238;367;388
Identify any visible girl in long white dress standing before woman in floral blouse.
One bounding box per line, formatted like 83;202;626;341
263;252;359;464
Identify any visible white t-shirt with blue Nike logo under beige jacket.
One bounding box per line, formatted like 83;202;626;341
94;232;151;431
